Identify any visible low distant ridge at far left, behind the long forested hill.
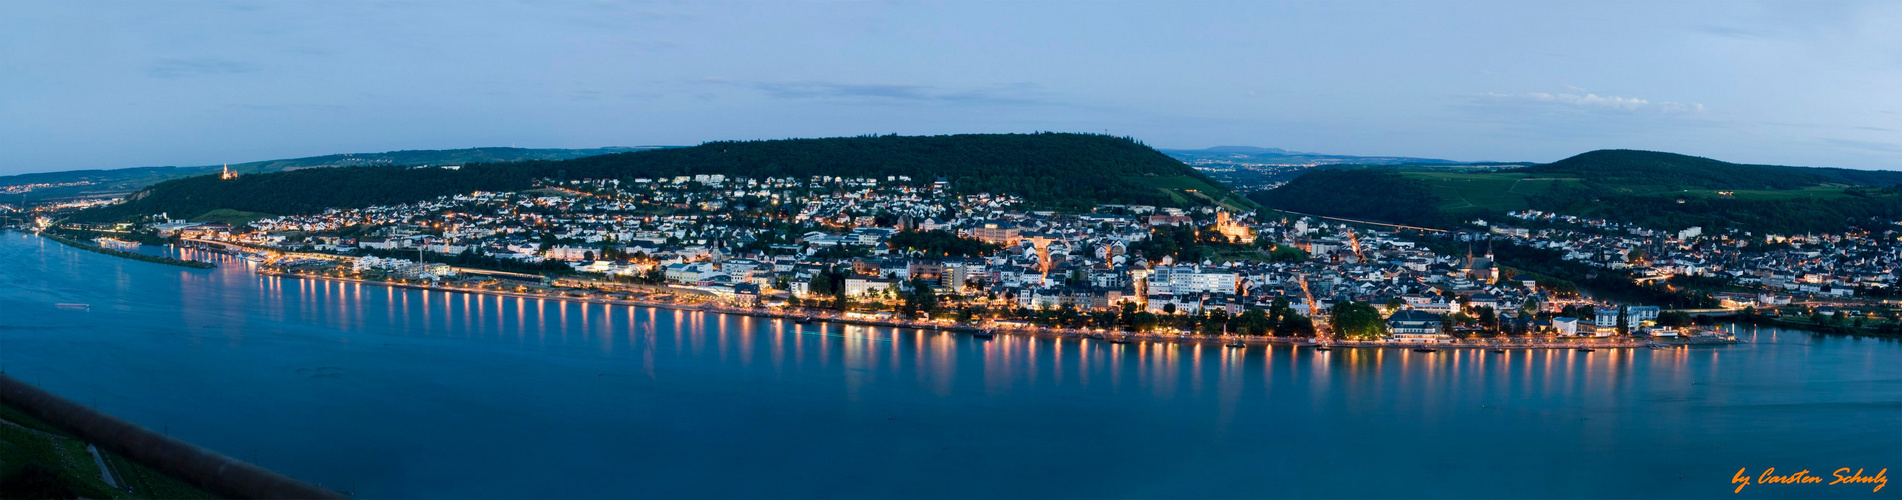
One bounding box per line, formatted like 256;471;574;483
0;146;662;202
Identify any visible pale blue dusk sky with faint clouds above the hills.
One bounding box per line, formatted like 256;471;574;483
0;0;1902;173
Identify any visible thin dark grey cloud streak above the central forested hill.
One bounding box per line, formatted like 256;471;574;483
702;78;1048;105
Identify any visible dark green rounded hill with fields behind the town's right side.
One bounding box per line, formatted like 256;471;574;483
1252;150;1902;234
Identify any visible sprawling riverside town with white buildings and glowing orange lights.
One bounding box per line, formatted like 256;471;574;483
18;175;1898;344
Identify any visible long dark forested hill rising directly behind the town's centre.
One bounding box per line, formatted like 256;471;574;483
76;133;1250;221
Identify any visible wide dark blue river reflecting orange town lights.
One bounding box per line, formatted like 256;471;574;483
0;232;1902;498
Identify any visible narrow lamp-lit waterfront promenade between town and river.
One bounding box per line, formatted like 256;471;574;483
255;268;1742;352
